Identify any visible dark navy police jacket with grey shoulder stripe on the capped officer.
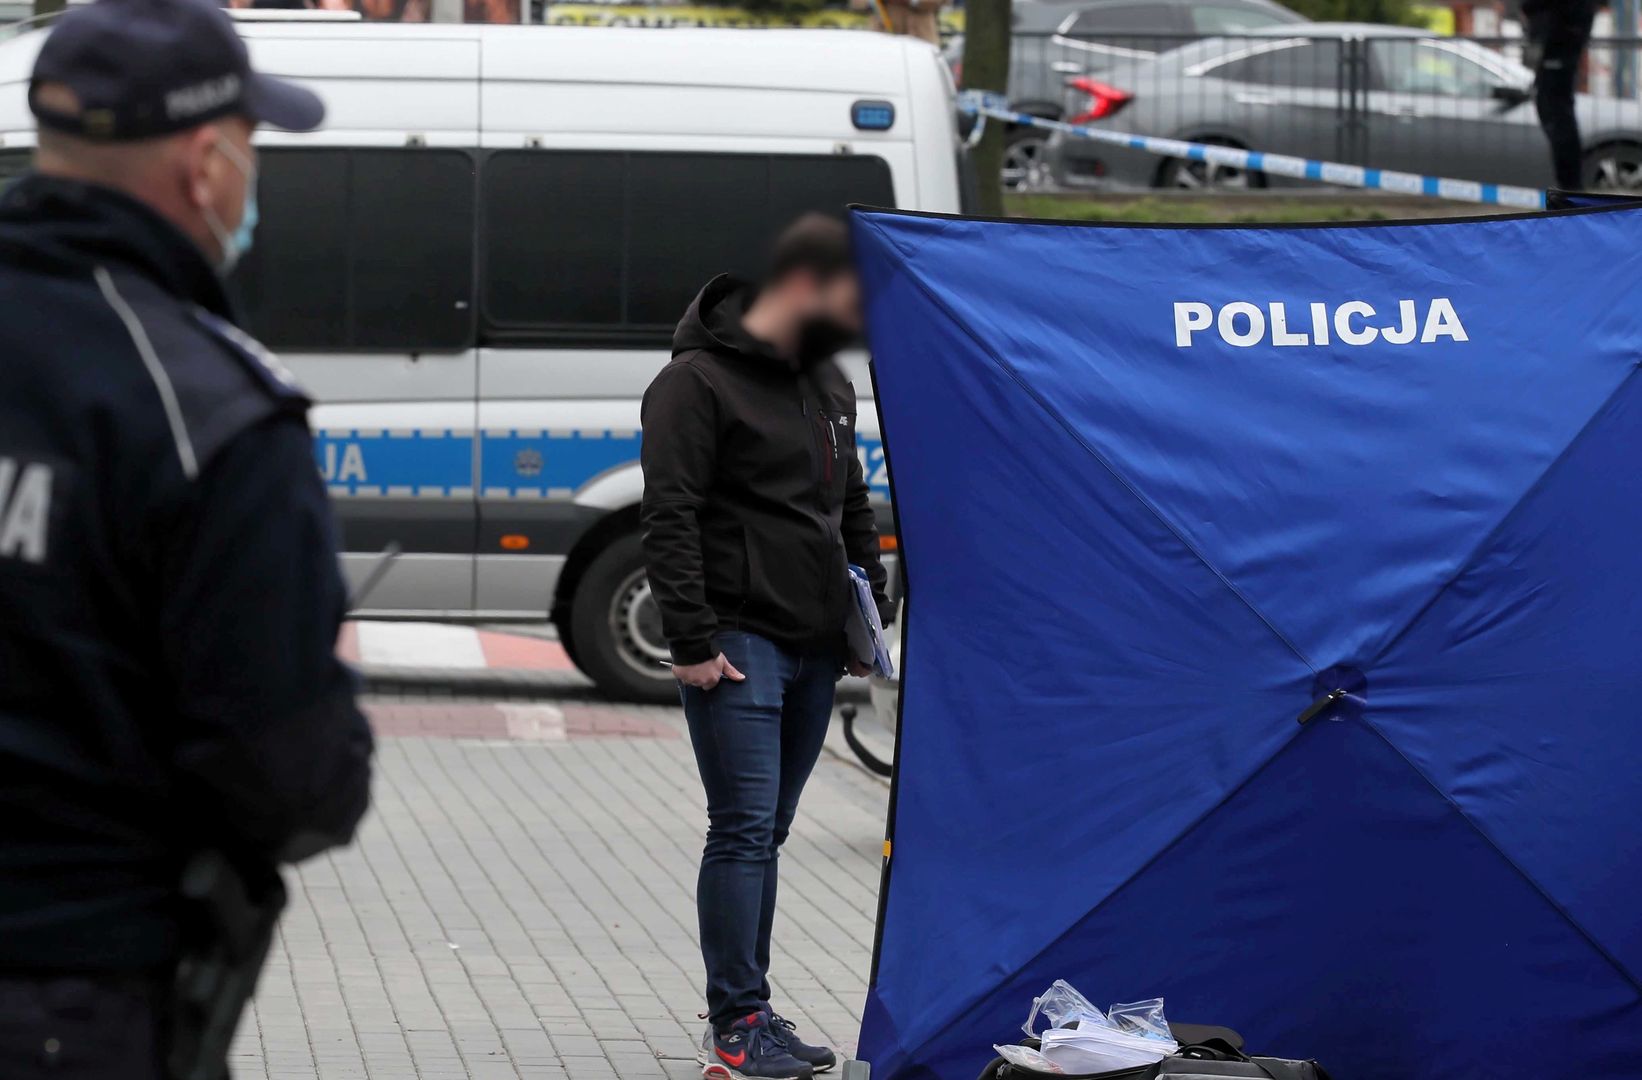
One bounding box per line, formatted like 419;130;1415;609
0;176;371;972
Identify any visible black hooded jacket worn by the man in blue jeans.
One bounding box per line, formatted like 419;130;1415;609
642;276;888;663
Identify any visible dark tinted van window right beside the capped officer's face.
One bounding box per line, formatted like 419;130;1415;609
235;148;475;351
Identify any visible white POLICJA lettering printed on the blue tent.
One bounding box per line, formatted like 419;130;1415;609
1174;297;1471;348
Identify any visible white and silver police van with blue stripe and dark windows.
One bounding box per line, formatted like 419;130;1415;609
0;20;959;701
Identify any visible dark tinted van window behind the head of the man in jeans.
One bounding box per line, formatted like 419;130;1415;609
481;149;895;345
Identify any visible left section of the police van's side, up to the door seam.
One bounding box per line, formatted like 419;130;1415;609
241;40;479;617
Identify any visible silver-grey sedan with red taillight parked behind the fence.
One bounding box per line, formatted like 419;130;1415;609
1048;23;1642;190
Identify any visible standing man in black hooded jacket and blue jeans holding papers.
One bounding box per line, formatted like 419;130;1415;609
642;215;888;1080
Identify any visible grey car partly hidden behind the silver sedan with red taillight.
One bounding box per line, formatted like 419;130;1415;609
944;0;1305;190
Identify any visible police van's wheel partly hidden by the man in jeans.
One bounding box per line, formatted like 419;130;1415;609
570;533;678;704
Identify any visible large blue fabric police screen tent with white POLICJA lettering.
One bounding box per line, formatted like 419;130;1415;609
854;208;1642;1080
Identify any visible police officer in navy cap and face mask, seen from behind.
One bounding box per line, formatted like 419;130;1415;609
0;0;371;1080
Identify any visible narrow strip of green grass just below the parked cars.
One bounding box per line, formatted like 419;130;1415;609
1003;195;1406;225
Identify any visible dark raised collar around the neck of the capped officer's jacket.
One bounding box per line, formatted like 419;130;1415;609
0;172;238;322
